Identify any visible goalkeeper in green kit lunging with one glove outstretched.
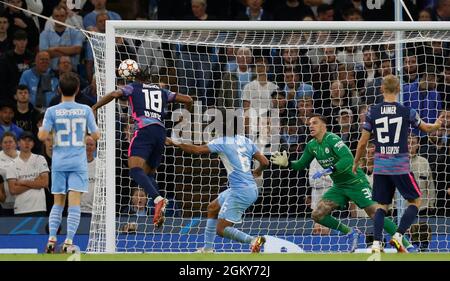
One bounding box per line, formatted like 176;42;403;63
270;114;414;252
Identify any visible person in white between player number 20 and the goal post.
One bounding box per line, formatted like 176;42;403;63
80;136;97;216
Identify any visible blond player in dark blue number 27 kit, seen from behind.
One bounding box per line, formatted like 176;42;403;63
353;75;442;253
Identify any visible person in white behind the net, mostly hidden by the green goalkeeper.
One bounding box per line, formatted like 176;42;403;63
308;158;333;235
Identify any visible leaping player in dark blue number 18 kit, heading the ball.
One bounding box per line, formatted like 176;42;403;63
92;65;192;227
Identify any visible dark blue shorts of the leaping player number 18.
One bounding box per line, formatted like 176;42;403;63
128;125;166;168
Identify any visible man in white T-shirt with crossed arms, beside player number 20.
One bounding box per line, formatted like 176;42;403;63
6;132;49;216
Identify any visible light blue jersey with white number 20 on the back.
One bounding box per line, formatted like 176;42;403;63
42;102;98;172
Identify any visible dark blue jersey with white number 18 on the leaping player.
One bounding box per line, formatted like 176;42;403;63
122;82;176;129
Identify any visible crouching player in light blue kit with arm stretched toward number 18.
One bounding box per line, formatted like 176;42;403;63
166;121;269;253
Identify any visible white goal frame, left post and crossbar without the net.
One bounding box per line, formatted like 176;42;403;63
101;20;450;253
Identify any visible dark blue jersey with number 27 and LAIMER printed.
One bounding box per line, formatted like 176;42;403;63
363;102;422;175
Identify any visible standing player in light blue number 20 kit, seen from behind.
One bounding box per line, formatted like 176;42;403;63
38;72;100;253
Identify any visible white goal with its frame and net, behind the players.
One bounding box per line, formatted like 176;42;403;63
88;21;450;252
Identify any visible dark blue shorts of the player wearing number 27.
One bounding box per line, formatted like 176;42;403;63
372;172;422;205
